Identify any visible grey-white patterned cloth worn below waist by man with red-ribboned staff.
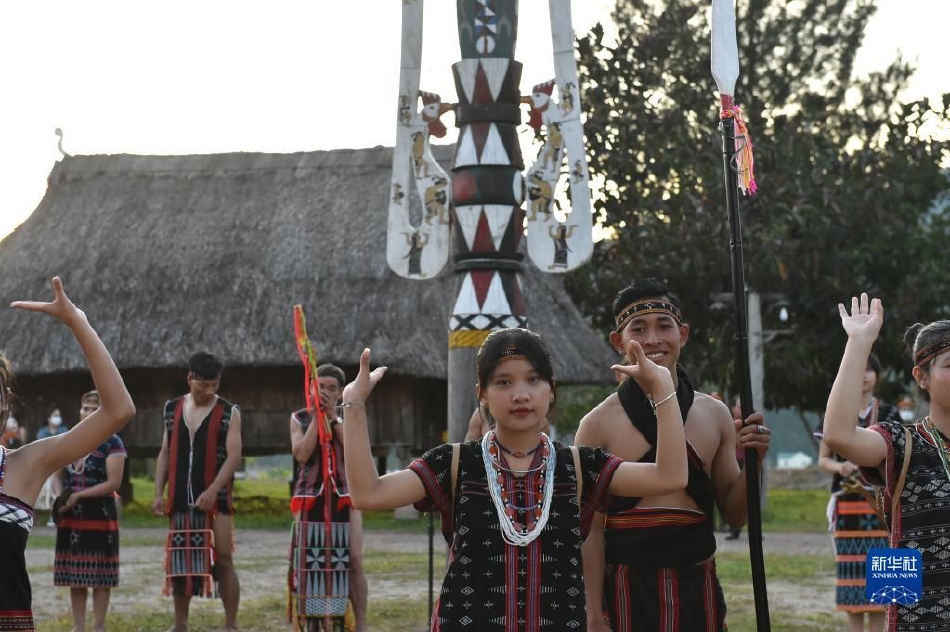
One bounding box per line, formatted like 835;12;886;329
287;497;350;630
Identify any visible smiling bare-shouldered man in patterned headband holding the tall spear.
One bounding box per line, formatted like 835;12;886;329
574;279;770;632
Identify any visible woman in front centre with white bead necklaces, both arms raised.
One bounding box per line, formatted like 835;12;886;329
343;329;687;632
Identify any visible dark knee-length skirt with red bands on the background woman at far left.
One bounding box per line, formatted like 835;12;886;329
53;496;119;588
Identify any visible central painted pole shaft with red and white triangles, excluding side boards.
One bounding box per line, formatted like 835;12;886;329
448;0;528;441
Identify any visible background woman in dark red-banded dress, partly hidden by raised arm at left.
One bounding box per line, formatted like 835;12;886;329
53;391;126;632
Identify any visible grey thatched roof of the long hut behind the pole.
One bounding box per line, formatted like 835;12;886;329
0;148;613;382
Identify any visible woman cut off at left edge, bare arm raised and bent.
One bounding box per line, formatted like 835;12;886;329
0;277;135;632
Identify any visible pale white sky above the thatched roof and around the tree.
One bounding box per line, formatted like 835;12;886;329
0;0;950;235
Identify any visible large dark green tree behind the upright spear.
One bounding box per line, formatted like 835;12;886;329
568;0;950;410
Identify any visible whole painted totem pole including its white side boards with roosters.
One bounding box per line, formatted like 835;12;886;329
386;0;593;441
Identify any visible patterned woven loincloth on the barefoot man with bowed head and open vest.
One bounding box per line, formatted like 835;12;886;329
162;509;217;597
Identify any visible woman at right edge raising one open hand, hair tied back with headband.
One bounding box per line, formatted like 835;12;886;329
824;294;950;631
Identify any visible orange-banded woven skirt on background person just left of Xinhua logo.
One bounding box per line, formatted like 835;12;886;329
833;494;888;612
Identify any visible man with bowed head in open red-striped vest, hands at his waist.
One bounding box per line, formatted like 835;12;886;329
152;353;241;632
